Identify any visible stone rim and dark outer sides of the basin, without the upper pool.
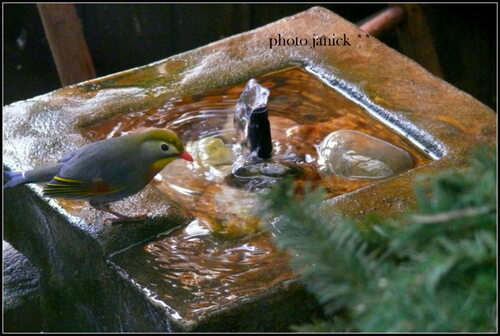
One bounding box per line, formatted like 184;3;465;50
3;7;496;331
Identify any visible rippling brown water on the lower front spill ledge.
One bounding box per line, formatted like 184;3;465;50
107;221;294;320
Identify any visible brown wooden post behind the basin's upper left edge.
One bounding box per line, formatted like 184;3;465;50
37;4;96;86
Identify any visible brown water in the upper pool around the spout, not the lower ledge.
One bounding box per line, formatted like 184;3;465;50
83;67;431;235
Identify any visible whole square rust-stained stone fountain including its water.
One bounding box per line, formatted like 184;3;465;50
3;7;496;331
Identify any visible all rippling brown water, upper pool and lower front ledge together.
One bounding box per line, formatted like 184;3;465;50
83;67;431;319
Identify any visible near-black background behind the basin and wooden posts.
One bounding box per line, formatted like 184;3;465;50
3;3;497;109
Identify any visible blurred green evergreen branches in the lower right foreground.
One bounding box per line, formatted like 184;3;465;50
263;148;497;332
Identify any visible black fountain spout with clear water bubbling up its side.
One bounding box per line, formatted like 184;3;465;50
234;79;273;160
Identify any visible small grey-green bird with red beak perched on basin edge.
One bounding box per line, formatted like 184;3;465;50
4;129;193;223
